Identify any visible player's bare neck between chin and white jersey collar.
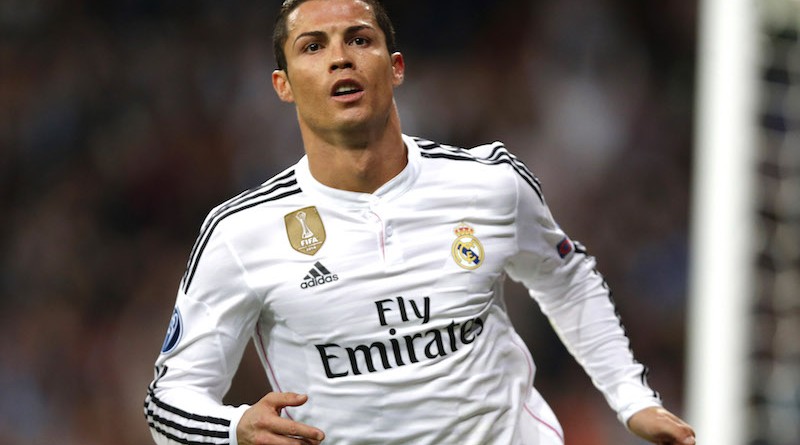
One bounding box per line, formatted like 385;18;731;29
300;110;408;193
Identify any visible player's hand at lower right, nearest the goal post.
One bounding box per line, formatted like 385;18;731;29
628;407;695;445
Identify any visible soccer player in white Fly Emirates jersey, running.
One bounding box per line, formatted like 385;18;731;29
145;0;694;445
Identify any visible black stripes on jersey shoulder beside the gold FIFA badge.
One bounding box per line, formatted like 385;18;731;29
183;170;301;292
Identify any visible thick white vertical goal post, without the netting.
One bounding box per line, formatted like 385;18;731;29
684;0;758;445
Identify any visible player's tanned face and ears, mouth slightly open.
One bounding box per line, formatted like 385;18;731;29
272;0;404;133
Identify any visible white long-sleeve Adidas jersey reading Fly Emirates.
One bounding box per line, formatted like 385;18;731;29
145;135;660;445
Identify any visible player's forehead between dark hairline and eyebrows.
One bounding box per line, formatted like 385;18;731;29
287;0;377;36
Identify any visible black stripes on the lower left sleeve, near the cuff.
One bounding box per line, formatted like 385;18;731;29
144;389;230;445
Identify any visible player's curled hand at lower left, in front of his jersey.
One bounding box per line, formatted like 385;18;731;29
236;392;325;445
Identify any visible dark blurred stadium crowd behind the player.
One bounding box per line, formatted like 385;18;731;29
0;0;696;445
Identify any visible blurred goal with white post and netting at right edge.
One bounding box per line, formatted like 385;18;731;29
685;0;800;445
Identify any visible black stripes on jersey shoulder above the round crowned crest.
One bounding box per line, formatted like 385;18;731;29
415;139;544;203
